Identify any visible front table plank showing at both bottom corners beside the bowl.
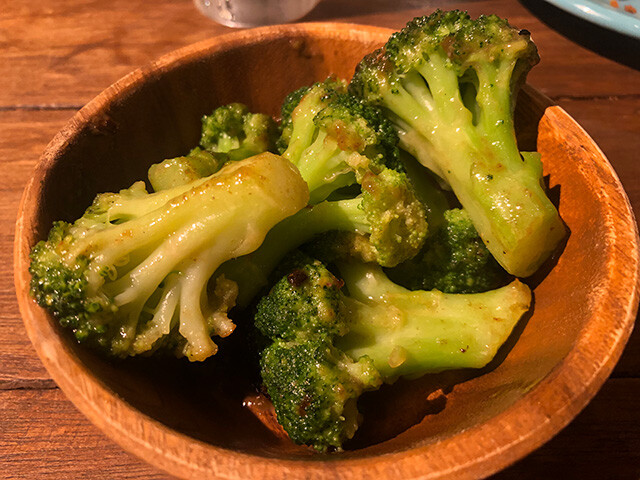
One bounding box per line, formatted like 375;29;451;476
0;379;640;480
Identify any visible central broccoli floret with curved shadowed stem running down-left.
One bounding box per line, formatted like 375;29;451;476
220;169;427;306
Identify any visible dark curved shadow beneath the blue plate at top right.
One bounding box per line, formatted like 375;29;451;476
520;0;640;70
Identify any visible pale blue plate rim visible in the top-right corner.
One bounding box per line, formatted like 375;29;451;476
545;0;640;39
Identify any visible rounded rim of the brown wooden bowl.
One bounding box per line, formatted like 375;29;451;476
14;22;640;479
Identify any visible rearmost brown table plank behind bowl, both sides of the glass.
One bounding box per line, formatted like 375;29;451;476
0;0;640;107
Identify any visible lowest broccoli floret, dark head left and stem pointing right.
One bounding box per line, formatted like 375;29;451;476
255;259;531;451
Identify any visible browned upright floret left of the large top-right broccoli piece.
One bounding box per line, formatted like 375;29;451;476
282;78;402;204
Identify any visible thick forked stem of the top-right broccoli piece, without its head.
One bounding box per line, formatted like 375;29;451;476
382;55;565;277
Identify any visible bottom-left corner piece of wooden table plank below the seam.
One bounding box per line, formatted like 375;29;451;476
0;388;169;480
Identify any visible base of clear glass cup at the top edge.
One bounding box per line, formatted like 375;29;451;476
194;0;320;28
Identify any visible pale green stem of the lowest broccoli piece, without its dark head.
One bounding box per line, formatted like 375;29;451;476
336;263;531;381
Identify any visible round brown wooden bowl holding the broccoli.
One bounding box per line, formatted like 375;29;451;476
15;24;638;480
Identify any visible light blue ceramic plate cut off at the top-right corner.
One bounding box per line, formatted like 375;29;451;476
547;0;640;38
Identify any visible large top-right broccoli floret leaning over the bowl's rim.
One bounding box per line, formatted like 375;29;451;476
349;11;565;277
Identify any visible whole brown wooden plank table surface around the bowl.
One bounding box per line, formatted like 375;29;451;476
0;0;640;480
